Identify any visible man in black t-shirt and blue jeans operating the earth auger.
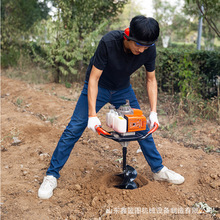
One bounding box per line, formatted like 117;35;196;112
38;16;184;199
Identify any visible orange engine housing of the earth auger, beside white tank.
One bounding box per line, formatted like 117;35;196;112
124;109;147;132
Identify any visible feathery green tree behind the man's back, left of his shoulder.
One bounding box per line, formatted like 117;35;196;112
33;0;126;82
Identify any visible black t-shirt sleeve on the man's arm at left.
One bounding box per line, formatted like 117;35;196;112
93;40;108;70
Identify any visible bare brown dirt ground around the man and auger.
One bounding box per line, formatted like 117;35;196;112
1;77;220;220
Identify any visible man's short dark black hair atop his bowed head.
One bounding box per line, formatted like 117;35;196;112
130;15;160;42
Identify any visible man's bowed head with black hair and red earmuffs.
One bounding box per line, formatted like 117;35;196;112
124;15;160;55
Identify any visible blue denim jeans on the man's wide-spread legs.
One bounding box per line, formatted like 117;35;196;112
46;82;163;178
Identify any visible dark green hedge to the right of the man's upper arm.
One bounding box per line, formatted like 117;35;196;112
156;48;220;98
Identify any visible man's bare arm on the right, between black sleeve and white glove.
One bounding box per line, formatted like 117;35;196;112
146;71;157;112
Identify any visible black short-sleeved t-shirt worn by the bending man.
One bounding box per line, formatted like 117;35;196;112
86;31;156;90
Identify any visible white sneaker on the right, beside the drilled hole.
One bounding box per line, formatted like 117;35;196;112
153;166;185;184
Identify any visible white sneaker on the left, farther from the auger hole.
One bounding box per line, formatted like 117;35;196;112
38;175;57;199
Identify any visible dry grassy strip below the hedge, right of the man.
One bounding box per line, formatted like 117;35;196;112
158;94;220;153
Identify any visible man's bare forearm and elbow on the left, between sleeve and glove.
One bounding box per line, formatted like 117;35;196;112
88;66;102;117
